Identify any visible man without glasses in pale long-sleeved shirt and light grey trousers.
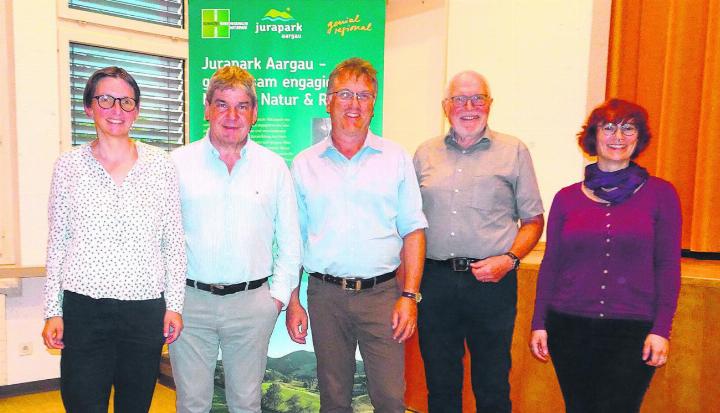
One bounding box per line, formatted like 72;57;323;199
170;66;301;413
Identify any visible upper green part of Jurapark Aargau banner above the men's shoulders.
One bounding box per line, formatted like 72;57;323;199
188;0;385;162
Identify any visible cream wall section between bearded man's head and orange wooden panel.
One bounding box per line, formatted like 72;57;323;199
447;0;611;211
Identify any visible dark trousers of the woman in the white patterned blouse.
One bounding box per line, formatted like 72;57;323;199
60;291;165;413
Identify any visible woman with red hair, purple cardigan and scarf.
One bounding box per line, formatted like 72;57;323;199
530;99;681;413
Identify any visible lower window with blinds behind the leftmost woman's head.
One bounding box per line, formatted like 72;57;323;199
70;43;185;151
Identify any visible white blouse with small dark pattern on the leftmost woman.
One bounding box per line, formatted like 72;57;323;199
45;142;185;318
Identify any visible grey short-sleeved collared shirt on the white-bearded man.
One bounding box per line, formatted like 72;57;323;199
414;128;543;260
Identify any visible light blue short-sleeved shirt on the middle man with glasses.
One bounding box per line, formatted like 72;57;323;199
292;132;427;278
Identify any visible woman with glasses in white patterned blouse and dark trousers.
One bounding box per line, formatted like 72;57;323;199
42;67;186;413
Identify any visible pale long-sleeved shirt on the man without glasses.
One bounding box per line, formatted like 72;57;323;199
172;136;300;304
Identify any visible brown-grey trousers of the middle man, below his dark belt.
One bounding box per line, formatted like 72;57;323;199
308;277;405;413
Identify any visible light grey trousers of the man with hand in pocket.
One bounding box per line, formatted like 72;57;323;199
170;283;278;413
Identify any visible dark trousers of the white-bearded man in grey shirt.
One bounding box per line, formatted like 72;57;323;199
418;260;517;413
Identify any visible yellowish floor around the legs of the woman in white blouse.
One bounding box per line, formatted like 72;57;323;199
0;384;175;413
